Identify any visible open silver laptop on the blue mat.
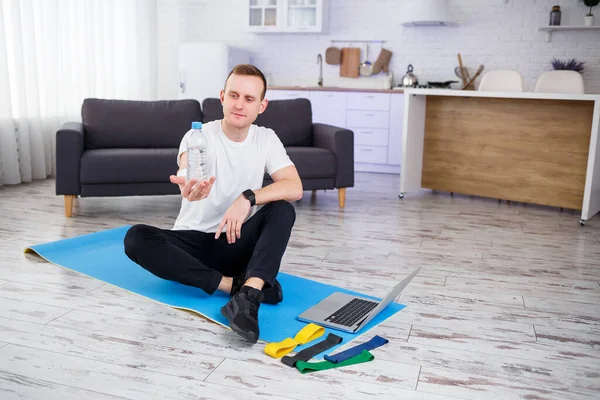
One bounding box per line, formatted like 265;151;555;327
296;267;421;333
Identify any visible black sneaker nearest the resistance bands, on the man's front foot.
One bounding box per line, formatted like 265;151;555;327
221;286;264;343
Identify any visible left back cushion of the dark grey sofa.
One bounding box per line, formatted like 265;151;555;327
81;99;202;150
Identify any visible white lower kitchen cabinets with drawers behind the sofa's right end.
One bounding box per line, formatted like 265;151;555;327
267;89;404;173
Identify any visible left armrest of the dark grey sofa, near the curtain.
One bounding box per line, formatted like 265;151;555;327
56;122;83;195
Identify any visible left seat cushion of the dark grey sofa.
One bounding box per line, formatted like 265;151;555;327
81;148;178;184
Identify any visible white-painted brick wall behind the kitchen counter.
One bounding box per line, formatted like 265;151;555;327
158;0;600;98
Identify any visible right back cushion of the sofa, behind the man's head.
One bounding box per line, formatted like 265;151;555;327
202;99;312;146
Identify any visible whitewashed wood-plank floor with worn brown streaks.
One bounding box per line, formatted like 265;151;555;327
0;174;600;400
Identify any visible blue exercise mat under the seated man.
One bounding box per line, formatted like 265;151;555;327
25;226;405;359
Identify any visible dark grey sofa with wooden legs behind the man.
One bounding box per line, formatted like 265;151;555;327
56;99;354;217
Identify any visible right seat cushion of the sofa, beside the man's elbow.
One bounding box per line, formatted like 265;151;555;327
285;146;336;179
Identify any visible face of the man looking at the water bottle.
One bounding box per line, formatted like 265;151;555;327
221;74;267;128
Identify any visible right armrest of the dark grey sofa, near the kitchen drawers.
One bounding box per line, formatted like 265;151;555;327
313;123;354;188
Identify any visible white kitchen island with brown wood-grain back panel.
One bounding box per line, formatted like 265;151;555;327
400;89;600;225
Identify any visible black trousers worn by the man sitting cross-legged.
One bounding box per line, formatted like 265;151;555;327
124;200;296;294
